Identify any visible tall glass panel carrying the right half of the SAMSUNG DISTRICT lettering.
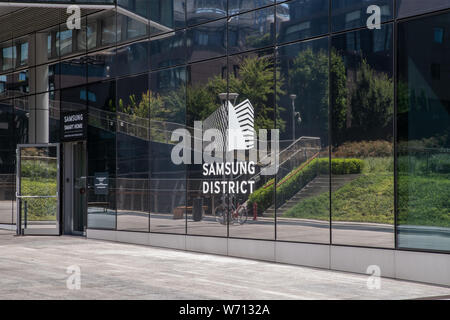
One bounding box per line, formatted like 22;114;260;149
227;50;276;240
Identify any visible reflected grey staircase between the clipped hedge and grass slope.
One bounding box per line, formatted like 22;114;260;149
263;174;359;217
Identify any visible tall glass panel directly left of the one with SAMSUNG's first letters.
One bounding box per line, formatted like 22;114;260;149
150;67;186;234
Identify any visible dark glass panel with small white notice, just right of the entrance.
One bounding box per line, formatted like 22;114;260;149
87;81;117;229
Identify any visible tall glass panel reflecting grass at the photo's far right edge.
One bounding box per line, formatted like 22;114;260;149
397;13;450;251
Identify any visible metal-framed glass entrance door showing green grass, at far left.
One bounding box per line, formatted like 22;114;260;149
16;144;60;235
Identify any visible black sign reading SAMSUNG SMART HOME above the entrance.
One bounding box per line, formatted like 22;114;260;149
60;111;87;141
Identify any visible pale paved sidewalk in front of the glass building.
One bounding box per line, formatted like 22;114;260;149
0;230;450;300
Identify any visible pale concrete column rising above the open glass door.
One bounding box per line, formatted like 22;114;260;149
28;33;50;143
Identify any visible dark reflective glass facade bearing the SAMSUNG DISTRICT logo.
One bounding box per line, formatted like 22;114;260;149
0;0;450;252
